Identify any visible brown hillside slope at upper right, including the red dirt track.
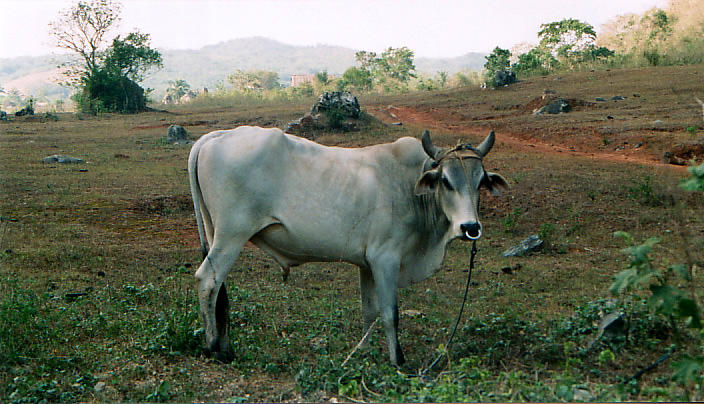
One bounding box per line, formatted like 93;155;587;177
369;65;704;169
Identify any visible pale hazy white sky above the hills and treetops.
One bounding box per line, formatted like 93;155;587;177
0;0;667;58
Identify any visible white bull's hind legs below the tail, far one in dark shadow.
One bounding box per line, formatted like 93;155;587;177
195;239;246;361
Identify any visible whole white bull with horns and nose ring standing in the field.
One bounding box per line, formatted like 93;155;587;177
188;126;507;365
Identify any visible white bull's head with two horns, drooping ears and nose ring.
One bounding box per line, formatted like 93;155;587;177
415;130;508;240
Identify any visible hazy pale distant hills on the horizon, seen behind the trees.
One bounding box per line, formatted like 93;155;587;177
0;37;486;98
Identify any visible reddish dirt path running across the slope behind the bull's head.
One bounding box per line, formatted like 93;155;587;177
370;106;686;172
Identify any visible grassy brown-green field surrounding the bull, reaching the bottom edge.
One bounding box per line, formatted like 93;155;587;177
0;66;704;402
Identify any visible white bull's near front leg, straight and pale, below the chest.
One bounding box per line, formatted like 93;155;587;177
372;258;405;366
